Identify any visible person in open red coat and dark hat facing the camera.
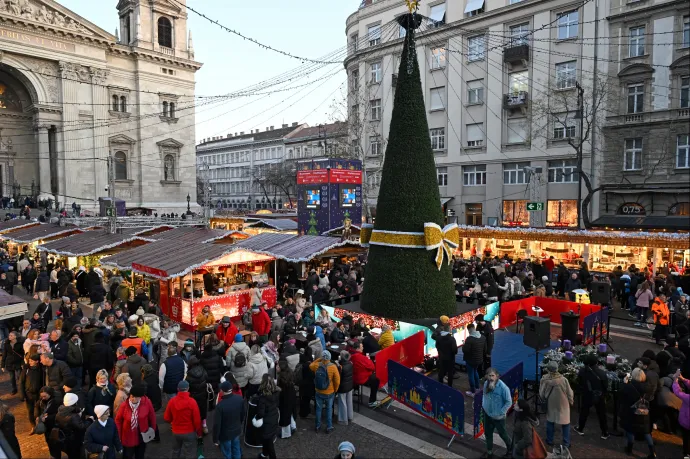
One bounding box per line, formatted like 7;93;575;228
115;384;156;459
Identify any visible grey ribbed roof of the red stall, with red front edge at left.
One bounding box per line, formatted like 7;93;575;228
125;240;230;279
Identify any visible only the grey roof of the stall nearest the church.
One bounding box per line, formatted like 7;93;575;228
38;231;147;257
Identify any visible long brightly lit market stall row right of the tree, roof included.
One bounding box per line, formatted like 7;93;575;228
456;226;690;272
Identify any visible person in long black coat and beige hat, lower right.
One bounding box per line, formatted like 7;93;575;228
618;368;656;459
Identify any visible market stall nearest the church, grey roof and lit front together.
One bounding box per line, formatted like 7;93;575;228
37;230;149;269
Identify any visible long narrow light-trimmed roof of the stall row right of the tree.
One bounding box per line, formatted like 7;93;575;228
459;225;690;250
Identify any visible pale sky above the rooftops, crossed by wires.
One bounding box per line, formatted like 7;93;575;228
58;0;361;143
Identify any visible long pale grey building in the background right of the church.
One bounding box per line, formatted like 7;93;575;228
196;122;305;210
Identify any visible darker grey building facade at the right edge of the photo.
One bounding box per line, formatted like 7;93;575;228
595;0;690;230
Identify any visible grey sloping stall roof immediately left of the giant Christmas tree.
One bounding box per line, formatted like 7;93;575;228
231;233;362;263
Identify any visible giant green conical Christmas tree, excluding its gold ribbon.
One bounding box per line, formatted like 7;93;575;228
361;14;455;319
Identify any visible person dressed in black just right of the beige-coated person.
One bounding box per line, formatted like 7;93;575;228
573;355;609;440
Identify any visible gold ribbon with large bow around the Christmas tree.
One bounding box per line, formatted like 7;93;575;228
359;223;460;270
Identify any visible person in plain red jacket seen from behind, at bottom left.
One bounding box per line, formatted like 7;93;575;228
163;379;202;458
